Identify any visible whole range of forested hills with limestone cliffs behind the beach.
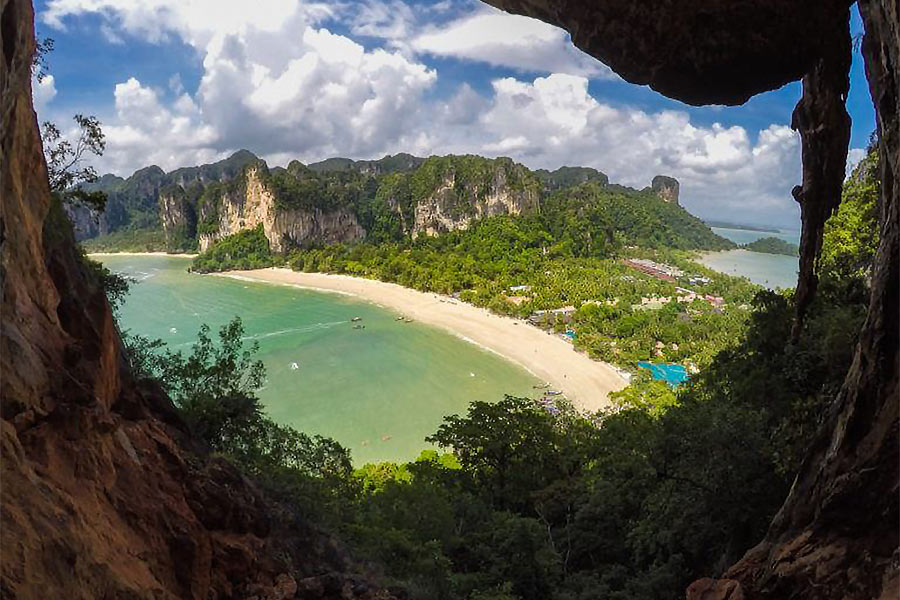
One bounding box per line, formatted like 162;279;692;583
69;150;733;252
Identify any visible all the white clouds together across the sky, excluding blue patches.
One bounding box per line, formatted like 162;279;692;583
35;0;800;225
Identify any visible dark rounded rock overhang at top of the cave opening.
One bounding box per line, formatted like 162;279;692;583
486;0;852;104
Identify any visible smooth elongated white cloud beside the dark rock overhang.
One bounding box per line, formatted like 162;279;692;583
410;8;615;79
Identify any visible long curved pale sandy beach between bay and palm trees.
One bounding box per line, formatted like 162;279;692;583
213;267;627;412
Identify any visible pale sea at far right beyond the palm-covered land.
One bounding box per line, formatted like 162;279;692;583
700;227;800;290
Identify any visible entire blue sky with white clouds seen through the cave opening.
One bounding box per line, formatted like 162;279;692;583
34;0;875;228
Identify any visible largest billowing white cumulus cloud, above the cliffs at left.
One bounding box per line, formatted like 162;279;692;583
42;0;437;174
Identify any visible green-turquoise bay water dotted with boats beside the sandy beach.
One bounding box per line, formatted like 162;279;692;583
102;256;539;464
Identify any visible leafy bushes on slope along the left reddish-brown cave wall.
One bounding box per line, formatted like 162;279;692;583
125;318;353;518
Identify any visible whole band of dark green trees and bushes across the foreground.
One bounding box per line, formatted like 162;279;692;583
118;282;861;600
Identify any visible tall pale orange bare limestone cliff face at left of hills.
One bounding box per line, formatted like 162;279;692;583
199;166;365;252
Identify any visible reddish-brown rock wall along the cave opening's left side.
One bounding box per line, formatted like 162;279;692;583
0;0;391;600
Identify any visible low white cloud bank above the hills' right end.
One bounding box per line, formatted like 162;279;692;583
430;74;800;225
